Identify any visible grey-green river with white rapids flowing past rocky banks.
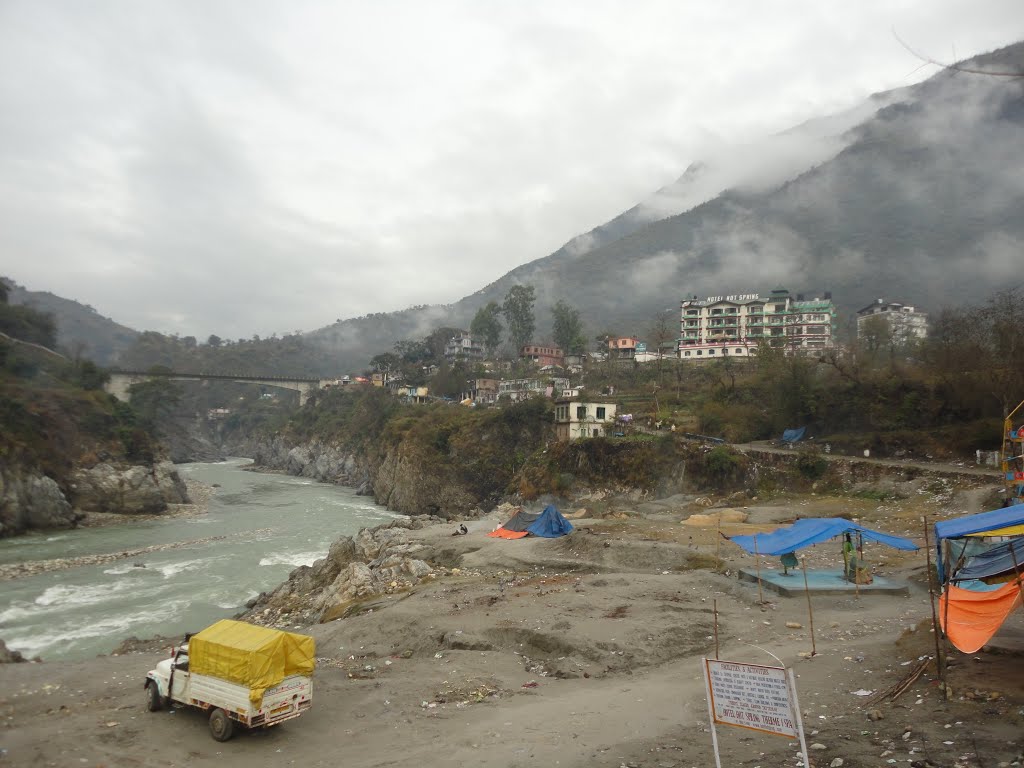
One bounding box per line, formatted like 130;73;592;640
0;459;395;660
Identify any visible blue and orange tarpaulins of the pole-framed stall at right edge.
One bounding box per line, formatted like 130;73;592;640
935;504;1024;653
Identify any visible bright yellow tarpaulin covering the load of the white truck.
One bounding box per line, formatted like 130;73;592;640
188;618;316;703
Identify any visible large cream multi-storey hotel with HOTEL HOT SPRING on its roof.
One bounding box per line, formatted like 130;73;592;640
679;288;836;360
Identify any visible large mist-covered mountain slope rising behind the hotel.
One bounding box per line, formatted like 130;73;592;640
14;43;1024;374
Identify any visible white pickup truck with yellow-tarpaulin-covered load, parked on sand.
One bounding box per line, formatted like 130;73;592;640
145;620;315;741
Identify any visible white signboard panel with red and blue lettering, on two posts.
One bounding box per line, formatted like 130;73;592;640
705;658;798;737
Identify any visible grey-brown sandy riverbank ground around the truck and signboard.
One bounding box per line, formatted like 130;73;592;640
0;489;1024;768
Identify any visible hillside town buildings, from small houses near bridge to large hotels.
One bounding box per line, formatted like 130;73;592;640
317;288;928;439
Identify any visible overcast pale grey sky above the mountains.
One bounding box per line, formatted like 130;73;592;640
0;0;1024;339
